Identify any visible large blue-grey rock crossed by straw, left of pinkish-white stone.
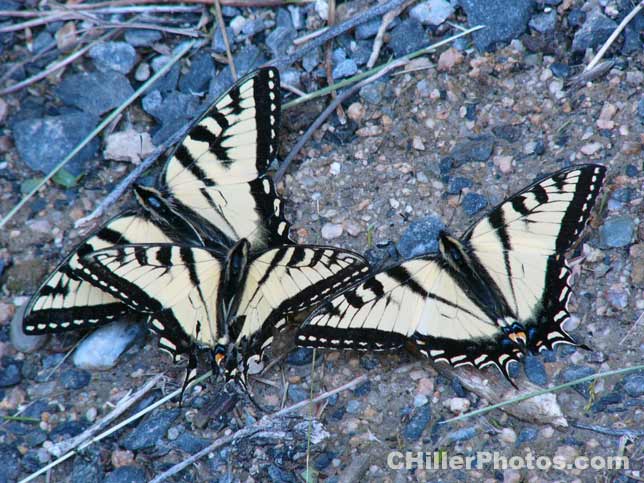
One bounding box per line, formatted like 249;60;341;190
12;112;99;176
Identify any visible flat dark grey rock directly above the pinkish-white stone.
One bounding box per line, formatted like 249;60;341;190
55;71;134;116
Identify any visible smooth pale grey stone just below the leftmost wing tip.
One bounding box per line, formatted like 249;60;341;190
73;321;147;370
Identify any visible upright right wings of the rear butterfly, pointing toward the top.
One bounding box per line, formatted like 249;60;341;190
160;67;292;250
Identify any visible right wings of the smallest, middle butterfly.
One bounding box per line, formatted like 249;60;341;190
231;245;369;356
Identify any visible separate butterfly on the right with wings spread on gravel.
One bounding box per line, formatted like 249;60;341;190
296;164;606;381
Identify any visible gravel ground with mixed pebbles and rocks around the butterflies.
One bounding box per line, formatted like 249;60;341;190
0;0;644;483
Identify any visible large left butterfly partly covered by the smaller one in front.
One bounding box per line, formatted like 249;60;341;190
23;68;292;335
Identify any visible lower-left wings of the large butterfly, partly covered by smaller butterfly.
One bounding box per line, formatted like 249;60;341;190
23;211;199;335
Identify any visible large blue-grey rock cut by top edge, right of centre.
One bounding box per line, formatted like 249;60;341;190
460;0;534;52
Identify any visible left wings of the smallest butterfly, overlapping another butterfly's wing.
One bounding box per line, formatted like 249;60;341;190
81;244;223;360
